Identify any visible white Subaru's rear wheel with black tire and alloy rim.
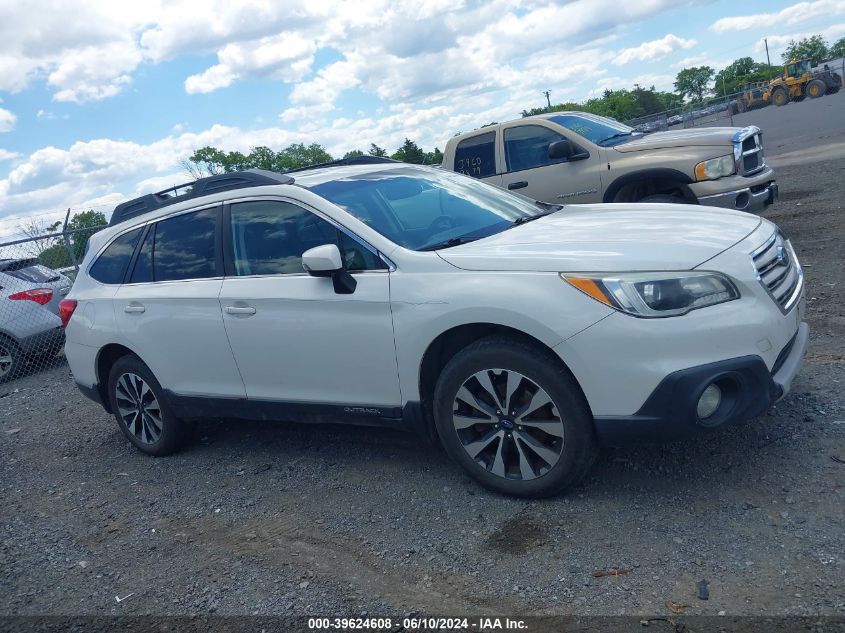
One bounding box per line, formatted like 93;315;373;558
109;354;189;457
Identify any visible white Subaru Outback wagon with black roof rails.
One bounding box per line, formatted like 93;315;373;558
61;157;808;496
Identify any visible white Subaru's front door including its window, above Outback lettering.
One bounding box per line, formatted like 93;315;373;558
220;200;401;417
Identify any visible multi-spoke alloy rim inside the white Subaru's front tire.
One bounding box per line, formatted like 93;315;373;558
452;369;564;480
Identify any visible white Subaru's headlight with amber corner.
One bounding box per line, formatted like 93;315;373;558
560;272;739;318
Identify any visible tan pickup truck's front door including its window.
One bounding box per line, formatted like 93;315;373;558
502;122;603;204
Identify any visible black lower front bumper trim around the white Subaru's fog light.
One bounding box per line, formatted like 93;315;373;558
595;323;810;445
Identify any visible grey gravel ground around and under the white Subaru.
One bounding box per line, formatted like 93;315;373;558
0;130;845;616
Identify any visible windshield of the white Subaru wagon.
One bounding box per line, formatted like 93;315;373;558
309;167;545;250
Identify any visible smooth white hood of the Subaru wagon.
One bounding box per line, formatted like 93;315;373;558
437;204;761;272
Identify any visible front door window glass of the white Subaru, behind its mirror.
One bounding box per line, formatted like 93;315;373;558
226;201;385;276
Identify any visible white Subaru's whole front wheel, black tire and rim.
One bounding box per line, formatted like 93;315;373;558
434;337;597;497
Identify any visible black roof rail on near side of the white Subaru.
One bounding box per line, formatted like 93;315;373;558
109;169;293;226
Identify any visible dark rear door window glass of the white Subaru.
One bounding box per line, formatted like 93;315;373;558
152;209;217;281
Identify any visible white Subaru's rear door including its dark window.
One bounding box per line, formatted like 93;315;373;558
114;205;246;398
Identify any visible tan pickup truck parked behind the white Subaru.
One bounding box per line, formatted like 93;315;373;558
443;112;778;212
